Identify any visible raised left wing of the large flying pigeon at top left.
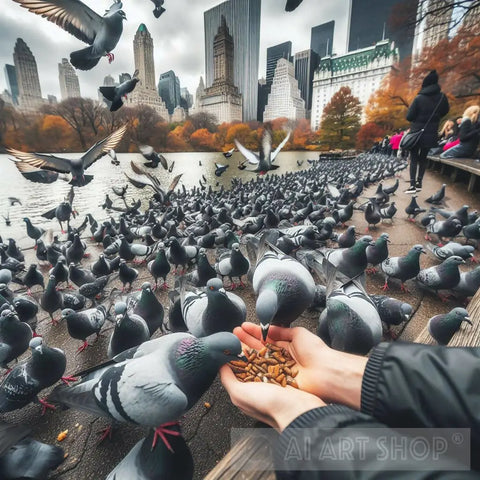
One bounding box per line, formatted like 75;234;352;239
14;0;103;45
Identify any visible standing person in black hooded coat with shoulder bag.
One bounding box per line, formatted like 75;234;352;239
405;70;450;193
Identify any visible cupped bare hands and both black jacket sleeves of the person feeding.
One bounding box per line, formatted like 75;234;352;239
220;323;480;480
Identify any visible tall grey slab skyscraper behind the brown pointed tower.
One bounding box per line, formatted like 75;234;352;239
204;0;261;121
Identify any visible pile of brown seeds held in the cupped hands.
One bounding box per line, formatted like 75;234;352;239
229;343;298;388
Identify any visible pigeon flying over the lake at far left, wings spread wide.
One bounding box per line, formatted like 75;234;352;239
7;125;127;186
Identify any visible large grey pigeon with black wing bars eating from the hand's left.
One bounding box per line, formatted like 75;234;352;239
49;332;242;450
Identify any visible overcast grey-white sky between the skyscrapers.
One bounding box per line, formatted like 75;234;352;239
0;0;349;100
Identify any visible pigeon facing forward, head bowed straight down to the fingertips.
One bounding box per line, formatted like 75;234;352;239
252;244;315;342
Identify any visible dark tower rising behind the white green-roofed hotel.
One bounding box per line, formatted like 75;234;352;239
348;0;419;60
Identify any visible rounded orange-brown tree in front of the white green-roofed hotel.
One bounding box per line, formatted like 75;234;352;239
320;87;362;149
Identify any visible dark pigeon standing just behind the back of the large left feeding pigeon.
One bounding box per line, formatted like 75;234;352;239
107;302;150;358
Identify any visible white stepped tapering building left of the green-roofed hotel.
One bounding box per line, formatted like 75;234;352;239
263;58;305;122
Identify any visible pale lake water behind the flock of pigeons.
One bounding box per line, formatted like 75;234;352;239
0;152;318;247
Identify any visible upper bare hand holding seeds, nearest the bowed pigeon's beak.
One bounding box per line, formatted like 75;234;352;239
233;322;368;410
